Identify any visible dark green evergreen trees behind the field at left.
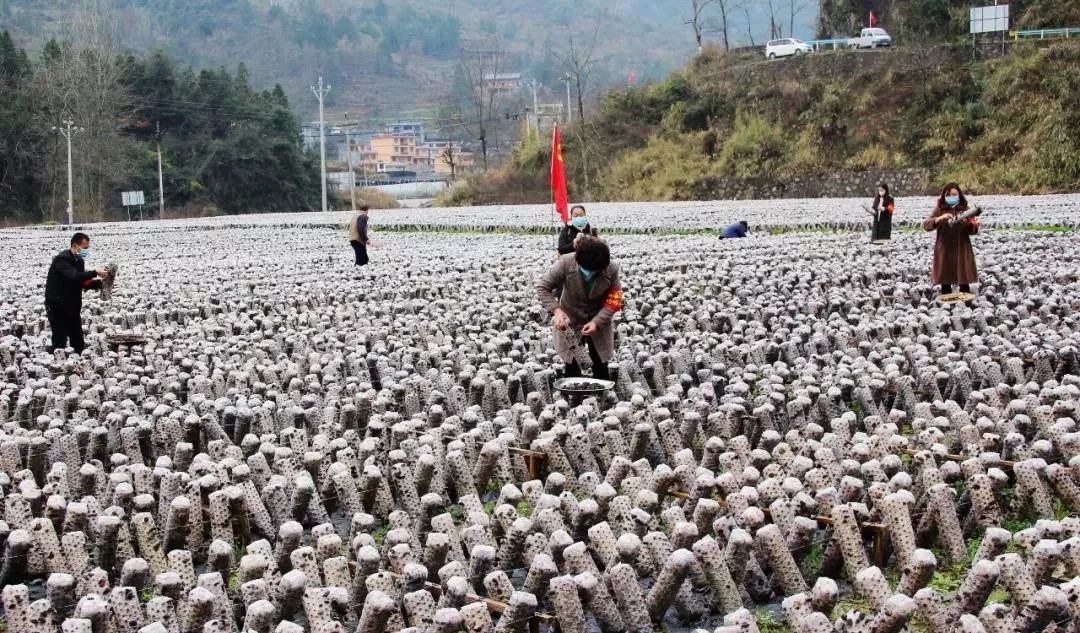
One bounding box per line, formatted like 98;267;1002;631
0;32;320;223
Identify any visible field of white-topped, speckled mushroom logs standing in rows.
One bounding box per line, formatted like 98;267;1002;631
0;197;1080;633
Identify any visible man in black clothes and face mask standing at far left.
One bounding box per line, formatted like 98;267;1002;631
45;233;108;353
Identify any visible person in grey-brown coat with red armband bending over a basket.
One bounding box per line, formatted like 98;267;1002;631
537;235;622;380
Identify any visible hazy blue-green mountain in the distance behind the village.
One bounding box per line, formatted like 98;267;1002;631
0;0;815;120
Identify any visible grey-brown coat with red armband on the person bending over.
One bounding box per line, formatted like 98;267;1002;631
537;253;622;363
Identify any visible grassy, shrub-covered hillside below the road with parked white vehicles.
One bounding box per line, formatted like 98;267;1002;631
438;40;1080;202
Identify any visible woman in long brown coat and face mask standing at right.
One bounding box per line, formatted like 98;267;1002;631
922;183;978;295
